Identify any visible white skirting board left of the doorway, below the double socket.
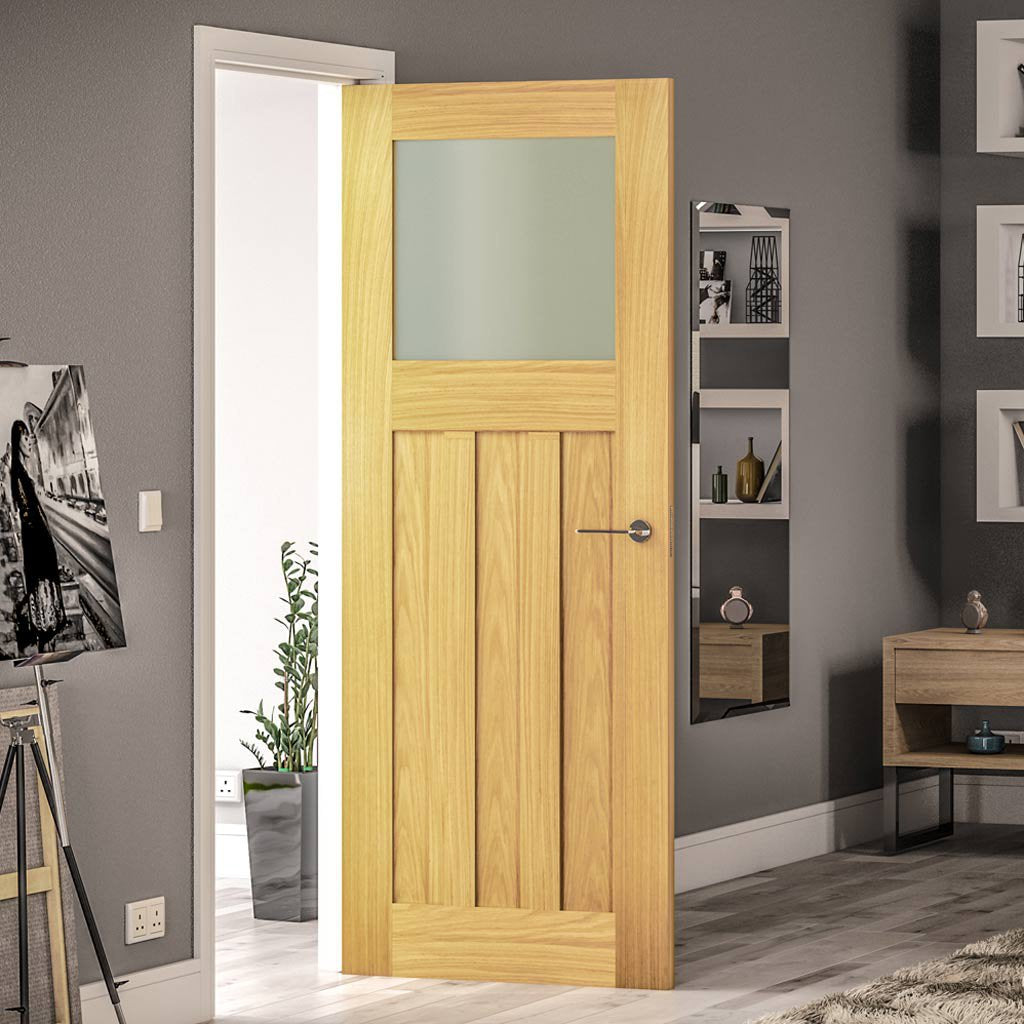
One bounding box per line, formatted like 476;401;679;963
82;959;208;1024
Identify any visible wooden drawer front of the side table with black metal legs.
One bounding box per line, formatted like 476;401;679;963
895;649;1024;708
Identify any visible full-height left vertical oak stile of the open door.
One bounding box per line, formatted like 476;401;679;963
339;85;393;975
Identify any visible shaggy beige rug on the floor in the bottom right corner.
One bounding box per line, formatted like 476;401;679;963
758;929;1024;1024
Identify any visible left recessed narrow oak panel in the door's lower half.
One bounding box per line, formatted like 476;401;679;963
393;430;425;903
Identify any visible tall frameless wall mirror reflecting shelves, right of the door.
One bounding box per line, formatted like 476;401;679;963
690;202;791;723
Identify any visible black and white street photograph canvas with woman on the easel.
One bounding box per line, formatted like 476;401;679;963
0;366;125;660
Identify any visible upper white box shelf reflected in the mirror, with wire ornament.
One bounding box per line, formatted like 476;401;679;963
693;203;790;339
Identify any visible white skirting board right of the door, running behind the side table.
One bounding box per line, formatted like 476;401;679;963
676;775;1011;893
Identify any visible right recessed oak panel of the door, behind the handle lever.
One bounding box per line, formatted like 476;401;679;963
562;433;614;911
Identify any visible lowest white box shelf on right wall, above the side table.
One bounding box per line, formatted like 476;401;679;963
977;391;1024;522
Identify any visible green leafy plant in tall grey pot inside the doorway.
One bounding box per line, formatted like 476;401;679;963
242;541;319;921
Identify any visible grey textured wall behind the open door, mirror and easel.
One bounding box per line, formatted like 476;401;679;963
0;0;937;979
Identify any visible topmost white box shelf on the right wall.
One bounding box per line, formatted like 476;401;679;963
977;20;1024;157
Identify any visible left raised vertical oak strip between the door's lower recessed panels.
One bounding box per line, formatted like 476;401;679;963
428;433;476;906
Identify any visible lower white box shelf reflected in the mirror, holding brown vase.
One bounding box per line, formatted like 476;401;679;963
694;388;790;519
